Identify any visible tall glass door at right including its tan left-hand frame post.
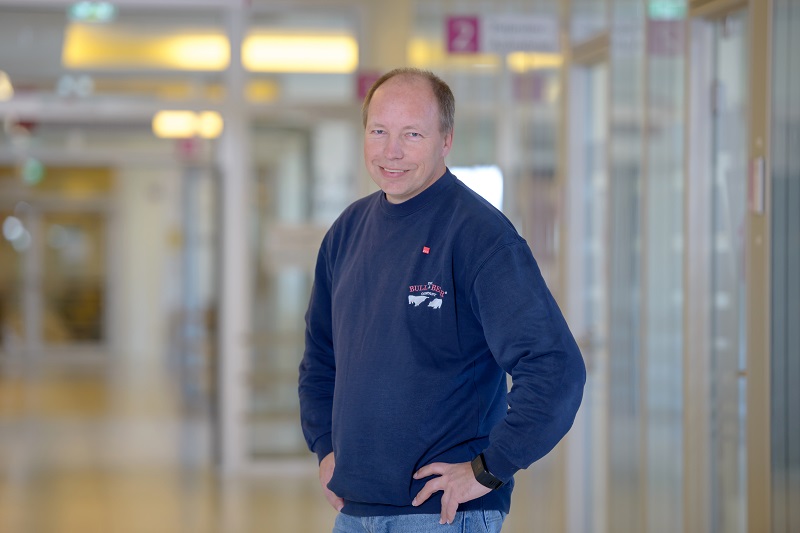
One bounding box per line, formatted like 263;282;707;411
684;10;750;533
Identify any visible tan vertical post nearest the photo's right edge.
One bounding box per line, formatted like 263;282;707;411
744;0;772;532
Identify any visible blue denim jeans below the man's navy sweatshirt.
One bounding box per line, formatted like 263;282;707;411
333;511;506;533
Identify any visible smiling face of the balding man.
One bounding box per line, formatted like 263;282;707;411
364;76;453;204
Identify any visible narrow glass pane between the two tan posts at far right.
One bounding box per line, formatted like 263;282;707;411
710;12;748;533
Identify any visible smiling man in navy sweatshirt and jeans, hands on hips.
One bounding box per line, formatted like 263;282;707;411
299;69;585;533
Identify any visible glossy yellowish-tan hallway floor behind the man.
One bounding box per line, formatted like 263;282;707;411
0;354;560;533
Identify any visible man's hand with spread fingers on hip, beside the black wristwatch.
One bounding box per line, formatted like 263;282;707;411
411;463;491;524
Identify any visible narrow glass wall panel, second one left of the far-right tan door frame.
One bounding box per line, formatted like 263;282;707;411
608;0;645;532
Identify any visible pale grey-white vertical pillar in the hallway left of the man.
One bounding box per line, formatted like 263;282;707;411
217;0;252;474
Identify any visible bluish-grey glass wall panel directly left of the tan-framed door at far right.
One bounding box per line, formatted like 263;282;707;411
643;6;685;533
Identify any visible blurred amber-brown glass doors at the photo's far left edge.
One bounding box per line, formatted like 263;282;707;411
0;182;109;359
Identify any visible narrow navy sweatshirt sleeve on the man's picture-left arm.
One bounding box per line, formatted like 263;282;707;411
298;239;336;461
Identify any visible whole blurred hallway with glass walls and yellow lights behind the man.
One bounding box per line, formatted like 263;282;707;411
0;0;800;533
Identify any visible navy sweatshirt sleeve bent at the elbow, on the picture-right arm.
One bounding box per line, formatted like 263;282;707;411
471;240;586;482
